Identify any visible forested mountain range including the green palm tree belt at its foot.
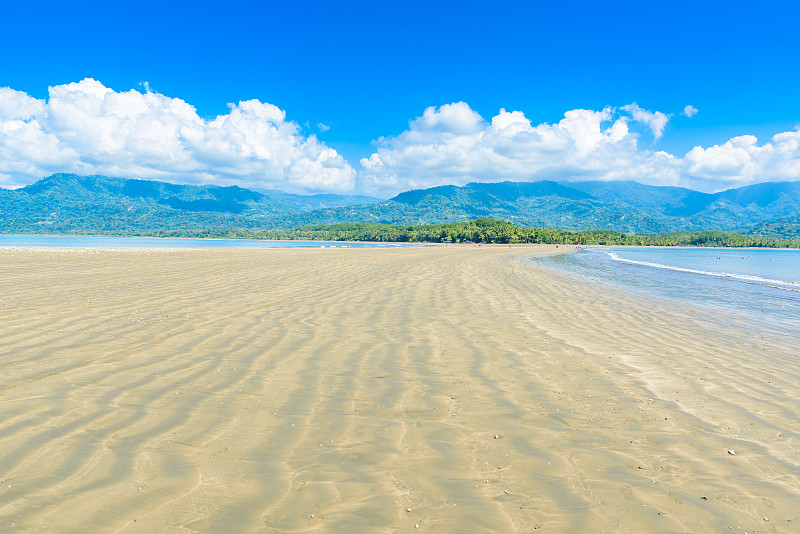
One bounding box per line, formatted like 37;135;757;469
0;174;800;246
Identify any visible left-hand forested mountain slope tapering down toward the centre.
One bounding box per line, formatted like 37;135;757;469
0;174;377;233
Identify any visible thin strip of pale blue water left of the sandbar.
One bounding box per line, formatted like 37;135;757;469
0;235;418;248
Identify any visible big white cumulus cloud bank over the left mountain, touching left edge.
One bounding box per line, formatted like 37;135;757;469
0;79;355;192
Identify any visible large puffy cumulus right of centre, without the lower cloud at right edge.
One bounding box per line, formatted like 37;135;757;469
360;102;680;196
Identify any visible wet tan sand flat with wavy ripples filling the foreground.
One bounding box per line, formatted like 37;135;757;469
0;247;800;534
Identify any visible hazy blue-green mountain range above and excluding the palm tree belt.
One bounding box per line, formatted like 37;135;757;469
0;174;800;238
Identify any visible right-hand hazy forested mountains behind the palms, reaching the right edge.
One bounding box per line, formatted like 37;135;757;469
288;181;800;236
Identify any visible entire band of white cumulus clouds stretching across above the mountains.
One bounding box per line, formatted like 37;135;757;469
0;84;800;196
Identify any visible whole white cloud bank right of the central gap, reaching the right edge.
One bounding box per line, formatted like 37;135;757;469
359;102;800;194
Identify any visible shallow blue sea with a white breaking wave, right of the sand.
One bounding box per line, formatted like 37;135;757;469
535;247;800;337
